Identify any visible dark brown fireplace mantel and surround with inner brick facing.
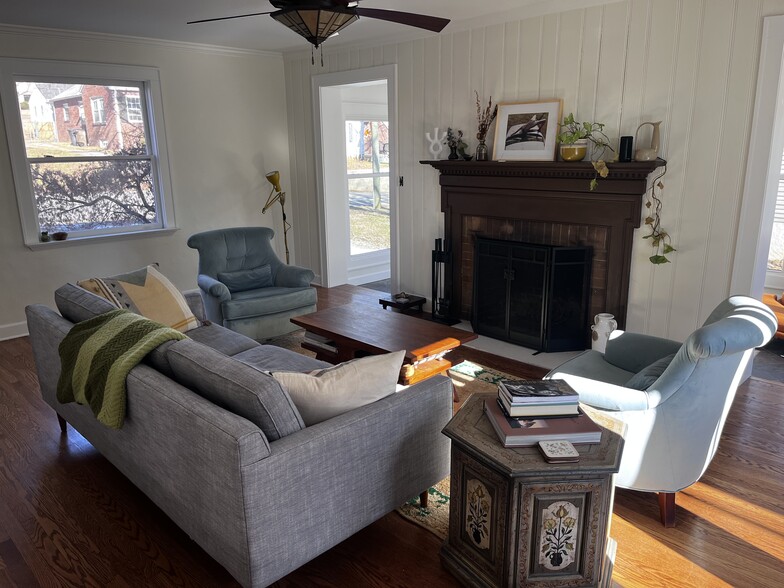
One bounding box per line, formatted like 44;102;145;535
420;159;666;328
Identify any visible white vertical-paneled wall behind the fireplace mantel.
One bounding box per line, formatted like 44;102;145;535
285;0;784;339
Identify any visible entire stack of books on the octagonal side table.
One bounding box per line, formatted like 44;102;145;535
485;380;602;447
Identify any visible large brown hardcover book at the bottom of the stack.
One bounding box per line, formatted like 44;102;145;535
485;401;602;447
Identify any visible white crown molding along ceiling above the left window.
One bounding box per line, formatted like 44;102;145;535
0;24;282;59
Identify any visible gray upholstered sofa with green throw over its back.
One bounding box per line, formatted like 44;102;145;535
26;284;452;586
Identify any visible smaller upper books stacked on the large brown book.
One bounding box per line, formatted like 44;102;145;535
498;380;580;418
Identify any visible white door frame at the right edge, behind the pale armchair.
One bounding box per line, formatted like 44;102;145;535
730;16;784;298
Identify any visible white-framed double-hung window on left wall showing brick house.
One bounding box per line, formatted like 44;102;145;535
0;59;174;246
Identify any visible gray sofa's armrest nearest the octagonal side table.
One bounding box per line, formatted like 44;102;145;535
243;376;452;586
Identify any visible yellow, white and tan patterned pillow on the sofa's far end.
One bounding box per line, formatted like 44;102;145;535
77;265;199;333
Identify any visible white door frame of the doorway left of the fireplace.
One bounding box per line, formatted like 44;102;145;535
311;64;400;292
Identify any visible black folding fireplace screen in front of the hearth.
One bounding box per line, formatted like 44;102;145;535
472;237;592;352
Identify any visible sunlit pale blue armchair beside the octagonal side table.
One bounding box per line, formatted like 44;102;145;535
545;296;777;527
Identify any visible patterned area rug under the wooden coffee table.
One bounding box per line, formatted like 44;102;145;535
266;331;514;539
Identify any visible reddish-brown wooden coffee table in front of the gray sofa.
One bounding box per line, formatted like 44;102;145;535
291;305;477;385
